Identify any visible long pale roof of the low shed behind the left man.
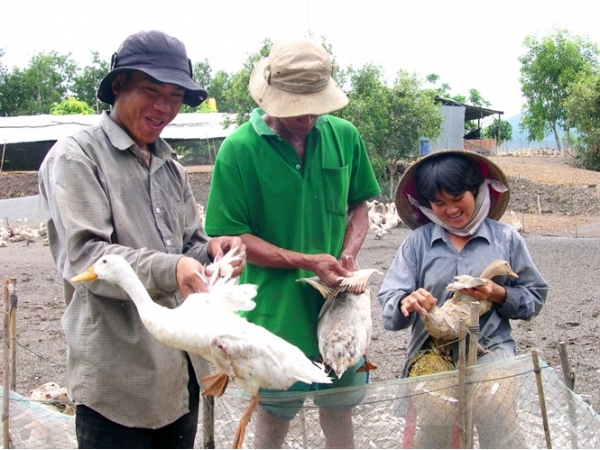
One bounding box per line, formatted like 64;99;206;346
0;113;236;145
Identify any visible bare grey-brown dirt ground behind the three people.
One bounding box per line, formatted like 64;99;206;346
0;157;600;411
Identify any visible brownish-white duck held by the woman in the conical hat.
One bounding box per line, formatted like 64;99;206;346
422;259;519;344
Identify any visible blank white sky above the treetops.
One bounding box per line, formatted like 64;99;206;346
0;0;600;118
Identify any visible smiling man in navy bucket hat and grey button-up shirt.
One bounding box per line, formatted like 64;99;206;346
39;31;244;448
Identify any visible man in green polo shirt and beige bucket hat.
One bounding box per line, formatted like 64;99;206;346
206;38;379;448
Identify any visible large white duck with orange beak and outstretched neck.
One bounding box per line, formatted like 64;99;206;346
71;255;331;448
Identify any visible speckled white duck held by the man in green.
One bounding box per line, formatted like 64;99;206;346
298;269;381;378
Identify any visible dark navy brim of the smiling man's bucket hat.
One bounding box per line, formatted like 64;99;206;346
98;67;208;108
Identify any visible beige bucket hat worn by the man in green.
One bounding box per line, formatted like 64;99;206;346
248;38;348;117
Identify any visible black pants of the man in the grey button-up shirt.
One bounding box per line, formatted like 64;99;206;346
75;359;200;448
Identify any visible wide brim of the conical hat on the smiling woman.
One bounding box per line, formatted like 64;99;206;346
394;150;510;230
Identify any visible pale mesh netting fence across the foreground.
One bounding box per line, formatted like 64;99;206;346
2;355;600;448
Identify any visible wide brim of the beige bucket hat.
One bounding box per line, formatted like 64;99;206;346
248;58;348;117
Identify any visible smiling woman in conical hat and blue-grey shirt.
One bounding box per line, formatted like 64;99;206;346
377;151;548;448
